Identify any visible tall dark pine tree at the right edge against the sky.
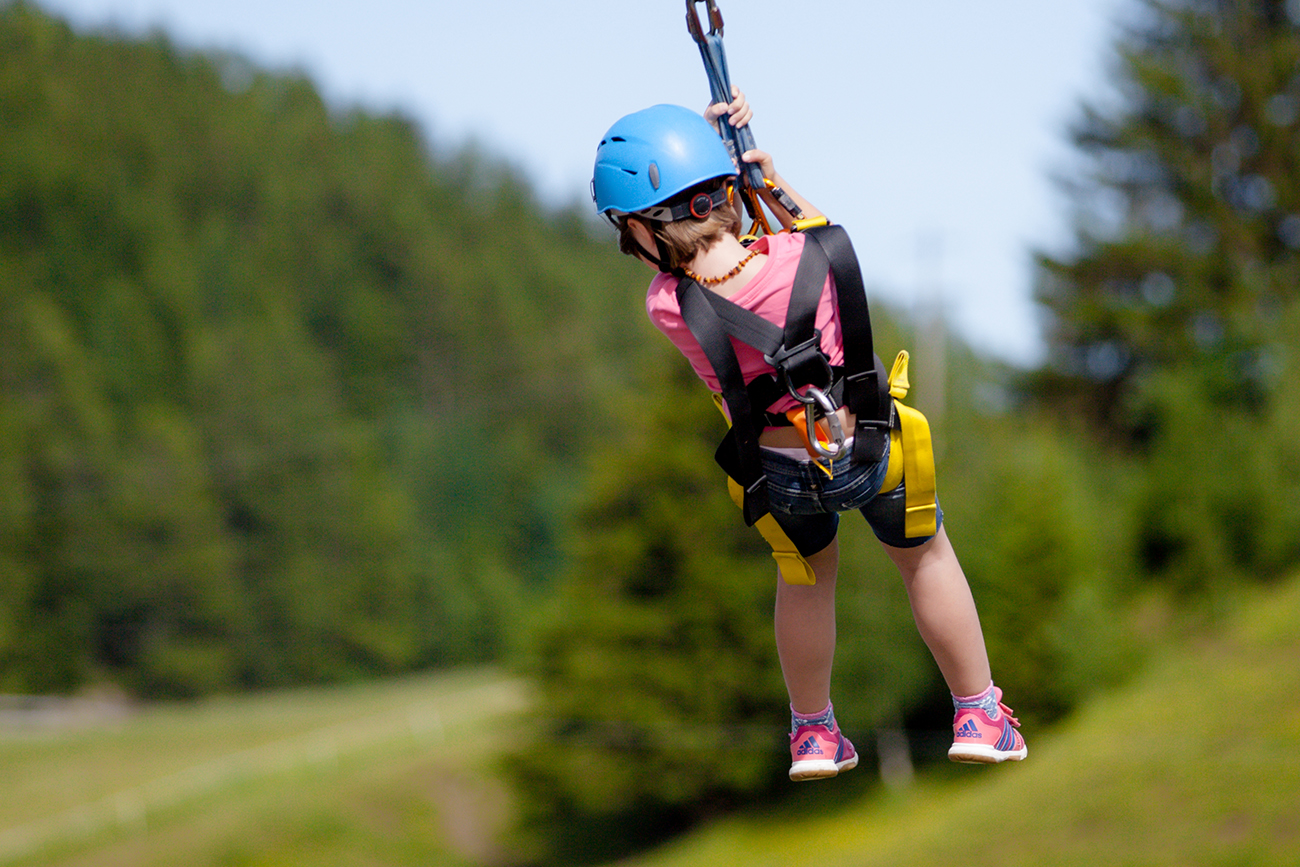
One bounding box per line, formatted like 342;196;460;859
1036;0;1300;589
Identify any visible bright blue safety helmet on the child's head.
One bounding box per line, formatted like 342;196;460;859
592;105;736;220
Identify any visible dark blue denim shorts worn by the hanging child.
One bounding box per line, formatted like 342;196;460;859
762;436;944;556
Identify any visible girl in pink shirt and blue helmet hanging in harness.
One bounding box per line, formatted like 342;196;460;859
592;88;1027;780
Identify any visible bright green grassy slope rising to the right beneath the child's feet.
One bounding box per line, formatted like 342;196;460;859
616;571;1300;867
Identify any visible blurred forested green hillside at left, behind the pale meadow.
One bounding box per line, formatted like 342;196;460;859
0;4;650;697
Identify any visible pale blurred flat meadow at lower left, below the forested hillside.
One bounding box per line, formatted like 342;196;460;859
0;672;523;867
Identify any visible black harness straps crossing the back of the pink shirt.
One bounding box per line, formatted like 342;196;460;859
677;226;894;526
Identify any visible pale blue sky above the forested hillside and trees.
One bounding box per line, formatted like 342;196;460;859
38;0;1136;364
